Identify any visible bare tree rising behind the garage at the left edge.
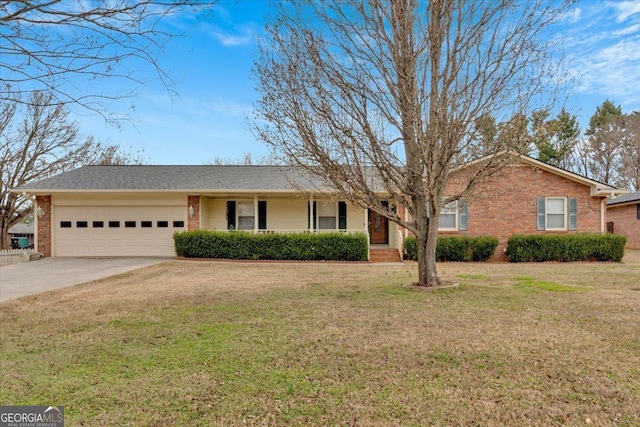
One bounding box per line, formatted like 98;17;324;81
0;92;139;249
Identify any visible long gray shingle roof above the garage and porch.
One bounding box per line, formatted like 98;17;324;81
14;165;328;192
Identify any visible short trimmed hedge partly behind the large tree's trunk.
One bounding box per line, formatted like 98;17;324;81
404;236;498;262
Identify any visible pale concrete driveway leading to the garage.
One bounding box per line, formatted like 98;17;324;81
0;258;173;302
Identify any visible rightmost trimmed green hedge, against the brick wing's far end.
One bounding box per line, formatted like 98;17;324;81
506;234;627;262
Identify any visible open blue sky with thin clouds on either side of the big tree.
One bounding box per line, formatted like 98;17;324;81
79;0;640;164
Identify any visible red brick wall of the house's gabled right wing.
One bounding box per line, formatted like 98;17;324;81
441;164;603;260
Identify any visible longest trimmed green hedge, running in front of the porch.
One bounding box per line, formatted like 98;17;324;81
173;230;369;261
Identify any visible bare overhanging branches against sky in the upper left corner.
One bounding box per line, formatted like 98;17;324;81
0;0;215;118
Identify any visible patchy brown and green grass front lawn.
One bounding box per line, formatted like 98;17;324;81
0;251;640;426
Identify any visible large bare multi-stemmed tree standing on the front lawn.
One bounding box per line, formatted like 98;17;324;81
255;0;566;286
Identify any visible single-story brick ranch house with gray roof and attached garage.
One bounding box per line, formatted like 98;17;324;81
13;156;624;260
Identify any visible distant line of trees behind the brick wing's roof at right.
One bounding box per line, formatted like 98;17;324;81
471;100;640;191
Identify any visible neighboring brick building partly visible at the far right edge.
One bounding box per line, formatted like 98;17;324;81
607;191;640;249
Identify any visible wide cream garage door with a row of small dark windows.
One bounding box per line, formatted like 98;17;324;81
54;206;186;256
